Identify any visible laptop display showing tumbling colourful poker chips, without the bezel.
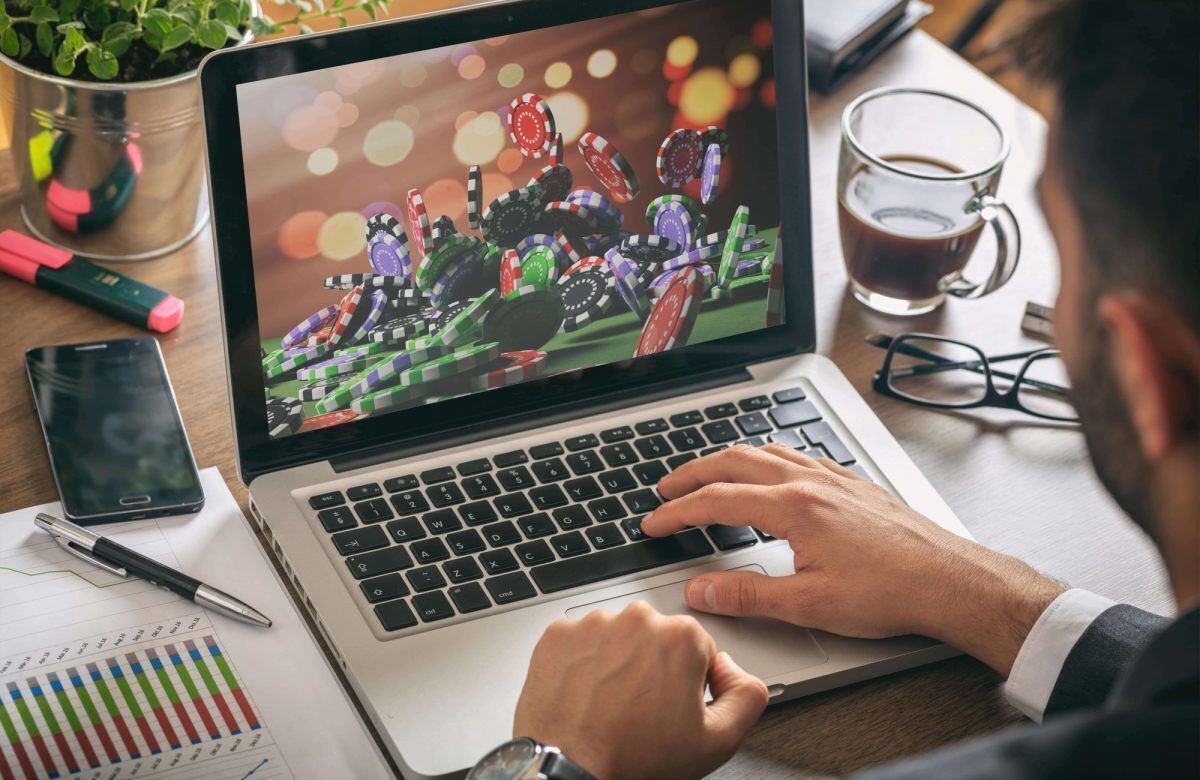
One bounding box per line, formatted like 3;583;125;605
236;0;782;438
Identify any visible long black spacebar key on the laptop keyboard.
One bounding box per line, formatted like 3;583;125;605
529;528;713;593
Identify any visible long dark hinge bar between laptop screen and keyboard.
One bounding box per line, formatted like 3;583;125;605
329;366;754;473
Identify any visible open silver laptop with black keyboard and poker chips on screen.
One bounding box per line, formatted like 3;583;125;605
200;0;967;778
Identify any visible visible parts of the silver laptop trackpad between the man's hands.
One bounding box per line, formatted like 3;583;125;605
566;565;826;679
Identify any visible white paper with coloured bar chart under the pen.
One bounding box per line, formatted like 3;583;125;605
0;469;390;780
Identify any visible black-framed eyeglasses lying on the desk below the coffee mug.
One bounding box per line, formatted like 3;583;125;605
871;334;1079;422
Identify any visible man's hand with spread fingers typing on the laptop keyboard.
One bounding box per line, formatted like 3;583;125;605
642;444;1063;676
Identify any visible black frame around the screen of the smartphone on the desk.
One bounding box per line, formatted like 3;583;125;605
25;336;204;524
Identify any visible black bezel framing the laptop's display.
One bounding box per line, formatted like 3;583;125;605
199;0;816;484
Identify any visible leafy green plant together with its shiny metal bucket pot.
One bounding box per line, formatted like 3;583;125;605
0;0;386;260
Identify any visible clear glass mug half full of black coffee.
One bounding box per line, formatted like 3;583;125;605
838;88;1021;314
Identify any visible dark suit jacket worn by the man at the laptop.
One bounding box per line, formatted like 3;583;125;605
856;605;1200;780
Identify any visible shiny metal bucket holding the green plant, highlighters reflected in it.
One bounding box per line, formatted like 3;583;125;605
0;16;258;260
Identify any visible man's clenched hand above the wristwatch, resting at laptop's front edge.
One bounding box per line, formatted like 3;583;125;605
512;601;767;780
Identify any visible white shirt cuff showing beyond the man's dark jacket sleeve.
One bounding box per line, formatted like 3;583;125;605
1004;588;1116;722
